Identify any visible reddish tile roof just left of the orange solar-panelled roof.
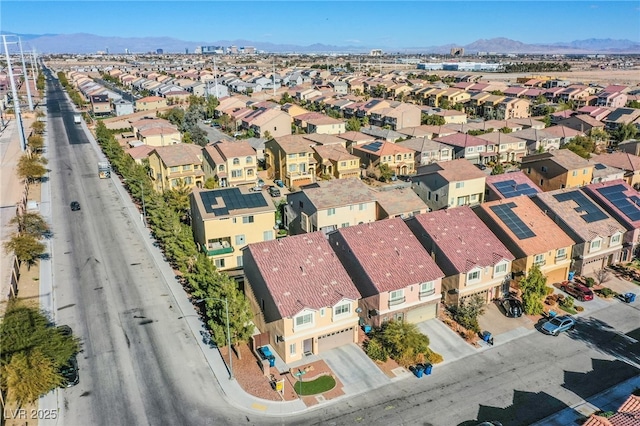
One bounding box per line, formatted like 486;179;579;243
415;206;515;273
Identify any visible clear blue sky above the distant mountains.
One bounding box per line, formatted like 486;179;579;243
0;0;640;48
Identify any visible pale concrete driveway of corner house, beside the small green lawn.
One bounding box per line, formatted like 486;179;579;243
319;343;391;395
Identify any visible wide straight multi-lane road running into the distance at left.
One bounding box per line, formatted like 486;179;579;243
40;67;246;425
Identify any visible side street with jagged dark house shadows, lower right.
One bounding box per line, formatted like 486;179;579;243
291;303;640;426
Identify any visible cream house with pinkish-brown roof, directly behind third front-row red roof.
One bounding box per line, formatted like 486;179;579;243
411;159;487;210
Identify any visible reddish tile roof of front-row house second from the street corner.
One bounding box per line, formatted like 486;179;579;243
334;218;444;293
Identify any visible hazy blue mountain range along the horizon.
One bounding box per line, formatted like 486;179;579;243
1;31;640;54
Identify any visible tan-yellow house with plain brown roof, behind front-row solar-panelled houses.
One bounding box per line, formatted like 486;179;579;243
520;149;593;191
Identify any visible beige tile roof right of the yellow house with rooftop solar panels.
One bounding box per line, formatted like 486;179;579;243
301;179;376;210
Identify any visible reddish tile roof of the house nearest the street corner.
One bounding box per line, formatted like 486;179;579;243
246;232;360;318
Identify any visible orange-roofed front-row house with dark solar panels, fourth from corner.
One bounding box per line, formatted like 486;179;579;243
474;195;574;284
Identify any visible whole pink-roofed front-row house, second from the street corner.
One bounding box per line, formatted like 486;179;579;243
329;218;444;327
